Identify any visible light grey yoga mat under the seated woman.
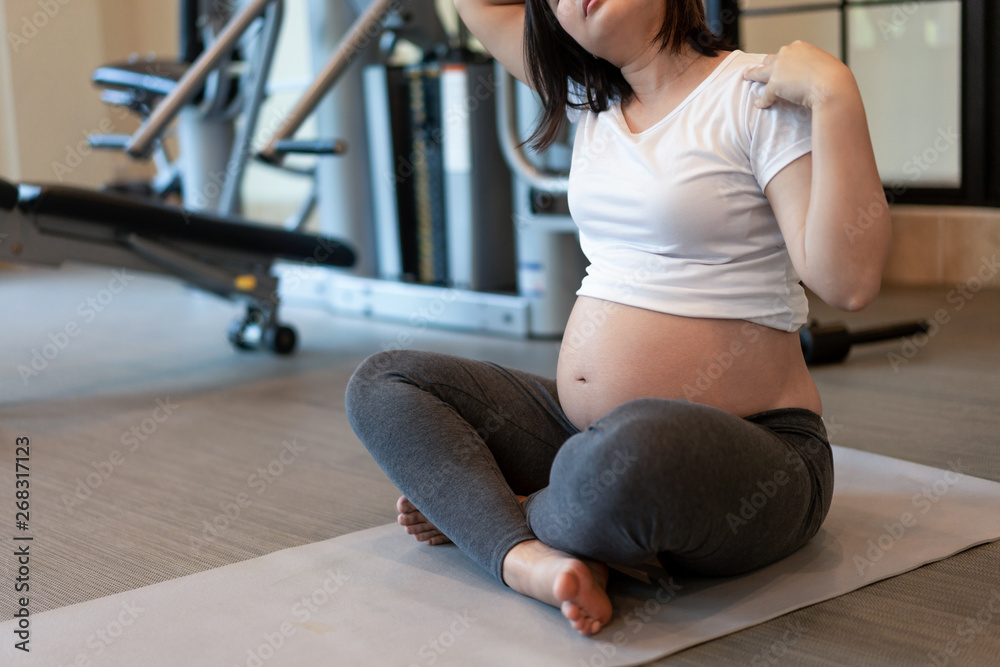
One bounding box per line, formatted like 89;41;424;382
0;447;1000;667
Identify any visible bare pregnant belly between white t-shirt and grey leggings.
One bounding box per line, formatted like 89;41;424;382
556;297;822;430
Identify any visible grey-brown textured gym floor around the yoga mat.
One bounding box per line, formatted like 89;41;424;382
0;266;1000;665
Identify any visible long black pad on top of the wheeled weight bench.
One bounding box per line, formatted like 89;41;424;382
15;181;354;266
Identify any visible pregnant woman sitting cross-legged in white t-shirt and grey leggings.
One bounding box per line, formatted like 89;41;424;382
346;0;890;634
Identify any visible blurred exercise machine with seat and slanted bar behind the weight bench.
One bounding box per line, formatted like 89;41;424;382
90;0;286;216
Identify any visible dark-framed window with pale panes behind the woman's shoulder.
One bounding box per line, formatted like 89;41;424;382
706;0;1000;206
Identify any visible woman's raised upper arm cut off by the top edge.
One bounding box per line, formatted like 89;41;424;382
455;0;534;88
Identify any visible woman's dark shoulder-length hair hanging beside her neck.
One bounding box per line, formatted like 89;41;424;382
524;0;733;151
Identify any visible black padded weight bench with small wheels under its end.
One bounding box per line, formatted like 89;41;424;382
0;179;355;354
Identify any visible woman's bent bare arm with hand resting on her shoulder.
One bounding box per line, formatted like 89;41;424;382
746;42;892;311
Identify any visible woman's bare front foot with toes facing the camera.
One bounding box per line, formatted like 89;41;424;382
503;540;611;635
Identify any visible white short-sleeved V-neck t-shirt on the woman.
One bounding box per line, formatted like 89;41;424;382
567;51;812;331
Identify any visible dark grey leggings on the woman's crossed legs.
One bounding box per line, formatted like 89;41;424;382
347;350;833;582
